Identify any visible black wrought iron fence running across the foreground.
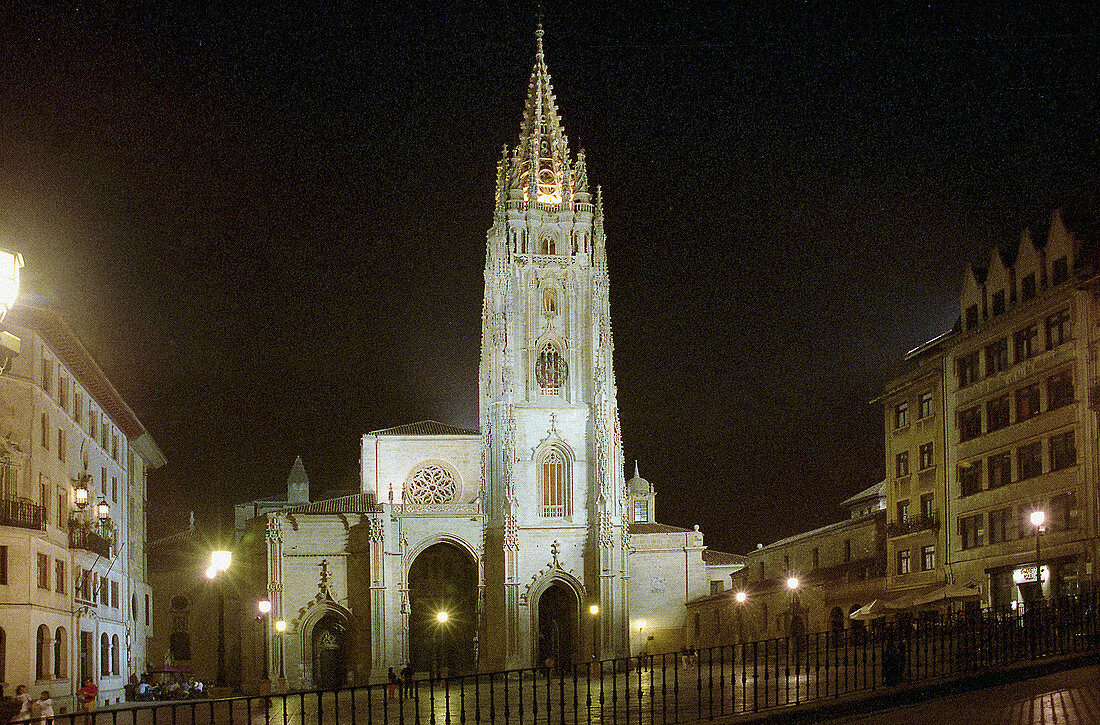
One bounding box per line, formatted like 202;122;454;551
55;596;1100;725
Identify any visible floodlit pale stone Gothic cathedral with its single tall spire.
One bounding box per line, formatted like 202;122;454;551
239;28;738;688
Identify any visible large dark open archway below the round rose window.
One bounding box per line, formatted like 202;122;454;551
408;542;477;674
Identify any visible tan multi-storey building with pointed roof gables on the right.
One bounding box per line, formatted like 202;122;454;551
880;211;1100;609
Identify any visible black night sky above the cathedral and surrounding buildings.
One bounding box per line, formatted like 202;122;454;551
0;1;1100;551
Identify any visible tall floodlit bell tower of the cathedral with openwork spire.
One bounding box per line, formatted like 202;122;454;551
480;25;630;668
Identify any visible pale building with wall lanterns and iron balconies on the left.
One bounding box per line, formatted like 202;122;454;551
0;303;165;708
